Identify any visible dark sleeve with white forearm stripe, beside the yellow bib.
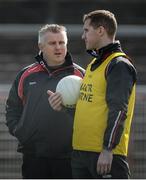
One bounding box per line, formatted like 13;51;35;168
103;57;136;149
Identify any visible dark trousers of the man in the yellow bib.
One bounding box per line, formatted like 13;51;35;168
72;151;130;179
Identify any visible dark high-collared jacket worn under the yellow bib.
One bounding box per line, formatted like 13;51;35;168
87;41;137;149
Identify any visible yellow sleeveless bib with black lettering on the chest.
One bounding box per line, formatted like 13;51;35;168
73;52;135;155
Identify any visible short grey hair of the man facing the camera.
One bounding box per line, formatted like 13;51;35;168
38;24;67;43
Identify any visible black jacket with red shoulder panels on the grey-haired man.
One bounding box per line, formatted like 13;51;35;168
6;53;84;158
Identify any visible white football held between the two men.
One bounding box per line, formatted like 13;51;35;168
56;75;82;108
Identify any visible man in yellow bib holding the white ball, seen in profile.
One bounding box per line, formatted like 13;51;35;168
49;10;136;179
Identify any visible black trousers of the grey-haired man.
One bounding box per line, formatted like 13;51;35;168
22;154;72;179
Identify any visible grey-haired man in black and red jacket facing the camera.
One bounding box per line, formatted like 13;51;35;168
6;24;84;179
